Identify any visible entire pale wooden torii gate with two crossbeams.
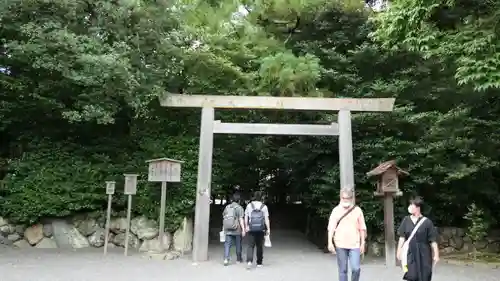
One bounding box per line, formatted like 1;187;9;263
160;94;395;262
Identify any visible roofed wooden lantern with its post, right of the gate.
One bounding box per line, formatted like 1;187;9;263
366;160;409;266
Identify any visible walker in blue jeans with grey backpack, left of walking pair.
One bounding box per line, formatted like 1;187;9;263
222;193;245;265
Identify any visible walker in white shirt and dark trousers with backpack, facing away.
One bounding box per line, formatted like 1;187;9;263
245;191;271;268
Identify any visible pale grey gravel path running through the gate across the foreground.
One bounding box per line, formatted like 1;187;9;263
0;230;500;281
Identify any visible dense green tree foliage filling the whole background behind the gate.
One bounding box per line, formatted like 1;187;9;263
0;0;500;233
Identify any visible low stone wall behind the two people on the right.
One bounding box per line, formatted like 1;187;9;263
367;227;500;256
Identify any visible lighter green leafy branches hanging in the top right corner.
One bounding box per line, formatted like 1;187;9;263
373;0;500;91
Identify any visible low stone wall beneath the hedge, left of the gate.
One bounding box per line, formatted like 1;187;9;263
0;214;193;255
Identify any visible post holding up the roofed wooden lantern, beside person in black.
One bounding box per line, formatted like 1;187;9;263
384;192;396;266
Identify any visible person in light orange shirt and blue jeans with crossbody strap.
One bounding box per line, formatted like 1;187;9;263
328;187;366;281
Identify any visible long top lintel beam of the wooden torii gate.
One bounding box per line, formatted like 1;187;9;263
160;94;395;112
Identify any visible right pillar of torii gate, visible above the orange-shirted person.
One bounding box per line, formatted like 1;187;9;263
338;110;354;188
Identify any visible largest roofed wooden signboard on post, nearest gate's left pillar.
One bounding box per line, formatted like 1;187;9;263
146;158;184;252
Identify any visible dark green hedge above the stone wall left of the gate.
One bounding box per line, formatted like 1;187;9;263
0;135;197;230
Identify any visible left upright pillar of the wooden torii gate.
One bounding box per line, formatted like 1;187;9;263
193;107;214;262
